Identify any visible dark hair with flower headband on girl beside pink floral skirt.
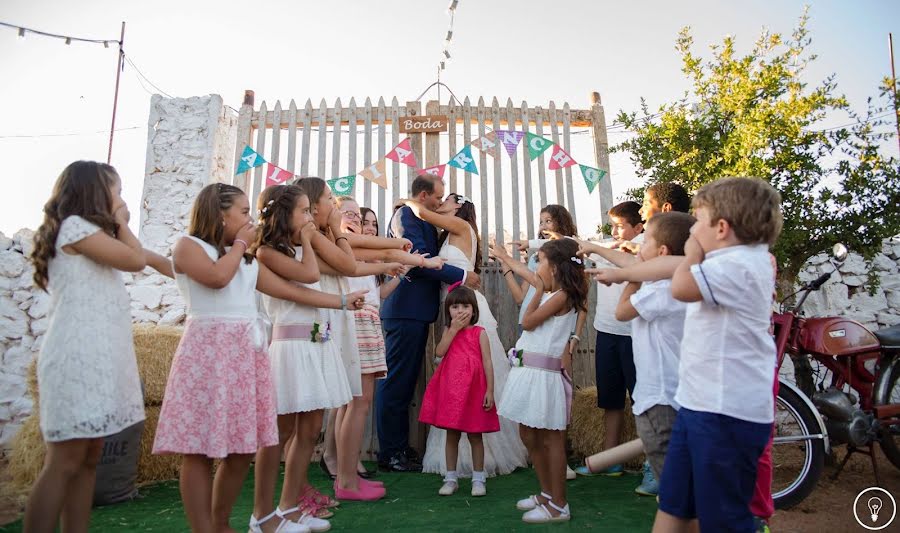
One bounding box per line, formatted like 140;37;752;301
250;185;306;257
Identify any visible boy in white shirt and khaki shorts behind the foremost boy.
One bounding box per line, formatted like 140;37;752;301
616;212;696;486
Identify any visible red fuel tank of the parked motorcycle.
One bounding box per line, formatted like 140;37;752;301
800;317;881;355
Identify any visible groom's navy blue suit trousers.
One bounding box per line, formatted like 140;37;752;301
375;318;431;462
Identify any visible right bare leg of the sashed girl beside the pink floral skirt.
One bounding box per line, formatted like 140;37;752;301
278;409;325;520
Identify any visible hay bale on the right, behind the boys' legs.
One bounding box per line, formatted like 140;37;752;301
568;387;644;469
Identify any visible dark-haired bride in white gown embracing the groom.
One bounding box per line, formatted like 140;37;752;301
404;193;527;477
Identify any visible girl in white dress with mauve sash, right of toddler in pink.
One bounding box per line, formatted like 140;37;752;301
498;239;588;523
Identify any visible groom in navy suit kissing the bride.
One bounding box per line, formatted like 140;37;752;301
375;176;480;472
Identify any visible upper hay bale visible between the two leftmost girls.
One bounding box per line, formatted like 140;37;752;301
133;325;184;406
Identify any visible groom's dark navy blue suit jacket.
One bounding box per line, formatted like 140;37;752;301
381;206;465;322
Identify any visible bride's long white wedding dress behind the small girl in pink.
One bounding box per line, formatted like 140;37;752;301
422;229;528;477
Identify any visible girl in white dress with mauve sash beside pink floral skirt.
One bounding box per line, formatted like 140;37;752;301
244;185;365;531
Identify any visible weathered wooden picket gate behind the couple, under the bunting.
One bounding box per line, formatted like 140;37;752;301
234;91;612;454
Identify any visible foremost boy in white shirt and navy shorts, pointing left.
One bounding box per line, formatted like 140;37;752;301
595;178;782;532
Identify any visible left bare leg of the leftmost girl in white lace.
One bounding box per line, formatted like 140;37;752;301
23;439;100;533
